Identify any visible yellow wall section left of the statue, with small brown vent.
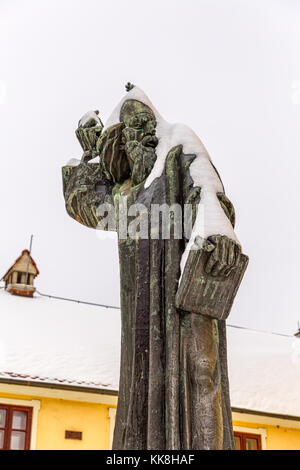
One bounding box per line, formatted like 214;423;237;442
0;393;114;450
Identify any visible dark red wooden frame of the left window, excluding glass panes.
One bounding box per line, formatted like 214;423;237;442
0;404;33;450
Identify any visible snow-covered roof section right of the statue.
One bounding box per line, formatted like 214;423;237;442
227;327;300;417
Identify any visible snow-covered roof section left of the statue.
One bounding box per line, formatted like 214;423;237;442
0;290;120;390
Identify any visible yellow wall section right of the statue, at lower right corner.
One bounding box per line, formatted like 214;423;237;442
233;417;300;450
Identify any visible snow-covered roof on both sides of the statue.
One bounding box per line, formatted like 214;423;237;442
0;290;300;417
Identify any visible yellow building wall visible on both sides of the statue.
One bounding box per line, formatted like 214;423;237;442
0;388;300;450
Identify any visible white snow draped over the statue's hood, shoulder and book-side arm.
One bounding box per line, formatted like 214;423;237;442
105;87;239;272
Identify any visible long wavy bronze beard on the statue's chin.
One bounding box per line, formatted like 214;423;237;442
125;135;158;186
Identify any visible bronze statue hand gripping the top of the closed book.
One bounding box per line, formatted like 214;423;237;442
205;235;241;277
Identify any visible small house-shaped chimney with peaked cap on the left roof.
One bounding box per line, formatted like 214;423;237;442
2;250;39;297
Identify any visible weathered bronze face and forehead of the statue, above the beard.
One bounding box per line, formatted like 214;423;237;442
120;99;158;148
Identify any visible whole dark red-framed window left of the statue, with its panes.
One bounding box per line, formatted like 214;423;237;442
0;404;32;450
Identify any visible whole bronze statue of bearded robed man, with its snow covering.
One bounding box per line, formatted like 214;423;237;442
63;84;248;450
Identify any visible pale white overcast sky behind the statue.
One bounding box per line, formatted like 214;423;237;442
0;0;300;333
